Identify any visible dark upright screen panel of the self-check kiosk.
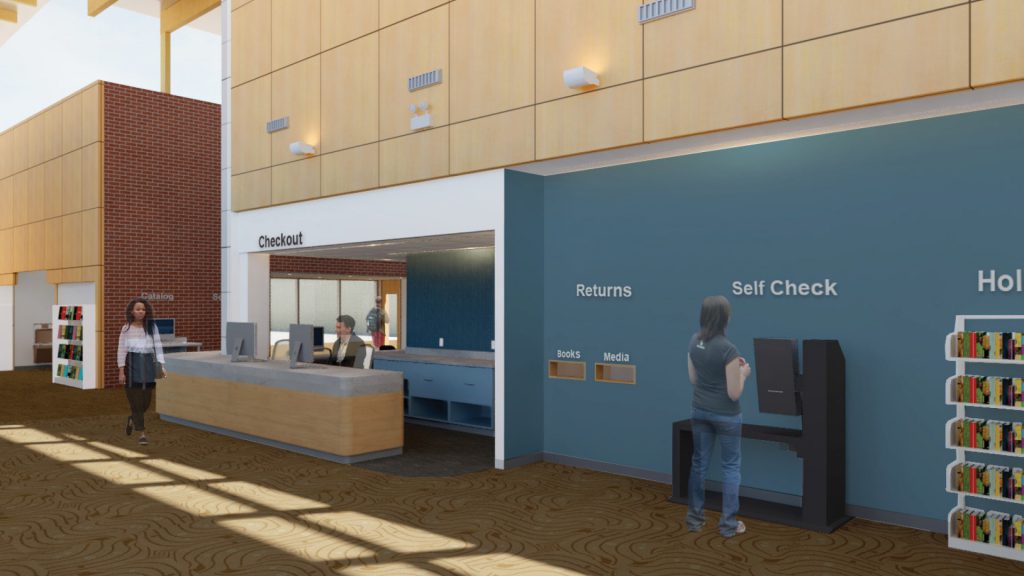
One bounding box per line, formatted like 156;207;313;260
754;338;802;416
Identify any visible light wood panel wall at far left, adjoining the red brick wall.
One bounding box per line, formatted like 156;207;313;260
0;82;103;377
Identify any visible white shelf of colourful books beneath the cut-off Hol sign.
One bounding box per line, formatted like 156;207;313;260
943;316;1024;562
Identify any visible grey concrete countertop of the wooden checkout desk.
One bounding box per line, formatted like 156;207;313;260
165;352;402;397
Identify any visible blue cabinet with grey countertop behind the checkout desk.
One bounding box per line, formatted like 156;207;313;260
374;358;495;429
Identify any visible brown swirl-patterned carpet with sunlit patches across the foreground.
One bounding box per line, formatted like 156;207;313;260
0;371;1022;576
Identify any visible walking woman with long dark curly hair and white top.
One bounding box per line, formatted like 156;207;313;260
118;298;164;446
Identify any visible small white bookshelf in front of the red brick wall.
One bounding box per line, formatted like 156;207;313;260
50;304;97;389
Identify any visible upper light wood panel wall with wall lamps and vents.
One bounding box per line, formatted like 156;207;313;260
230;0;1024;210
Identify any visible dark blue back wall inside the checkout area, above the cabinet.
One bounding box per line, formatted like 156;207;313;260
406;248;495;352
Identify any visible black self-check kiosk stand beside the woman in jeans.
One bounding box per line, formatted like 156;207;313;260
670;340;850;533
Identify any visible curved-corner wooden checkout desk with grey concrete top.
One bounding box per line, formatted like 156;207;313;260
157;352;403;464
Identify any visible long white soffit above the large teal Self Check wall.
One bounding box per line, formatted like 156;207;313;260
509;82;1024;176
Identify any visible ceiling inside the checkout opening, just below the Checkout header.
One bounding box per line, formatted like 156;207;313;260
260;231;495;262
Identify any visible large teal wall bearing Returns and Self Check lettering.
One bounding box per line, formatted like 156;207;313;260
506;107;1024;519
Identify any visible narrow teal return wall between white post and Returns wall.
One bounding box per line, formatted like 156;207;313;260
505;171;545;459
